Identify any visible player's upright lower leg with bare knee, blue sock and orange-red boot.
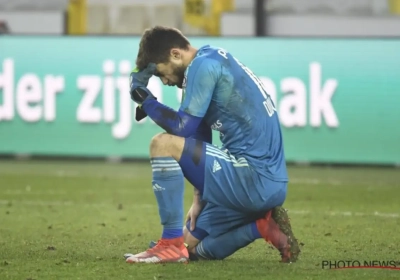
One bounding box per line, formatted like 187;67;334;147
125;133;188;263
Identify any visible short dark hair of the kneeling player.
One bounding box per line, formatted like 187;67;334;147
136;26;190;70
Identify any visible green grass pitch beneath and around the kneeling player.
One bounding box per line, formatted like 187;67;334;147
0;161;400;280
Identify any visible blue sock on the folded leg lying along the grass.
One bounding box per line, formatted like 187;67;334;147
196;222;261;260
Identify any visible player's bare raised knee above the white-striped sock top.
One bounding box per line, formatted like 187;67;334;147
150;133;185;160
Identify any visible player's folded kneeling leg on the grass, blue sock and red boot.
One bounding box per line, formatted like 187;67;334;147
180;186;299;262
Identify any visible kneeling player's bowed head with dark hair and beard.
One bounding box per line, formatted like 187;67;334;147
136;26;196;88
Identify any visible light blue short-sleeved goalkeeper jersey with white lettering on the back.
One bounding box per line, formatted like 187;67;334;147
180;45;288;182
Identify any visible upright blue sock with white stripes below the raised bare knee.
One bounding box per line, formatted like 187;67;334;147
150;157;184;239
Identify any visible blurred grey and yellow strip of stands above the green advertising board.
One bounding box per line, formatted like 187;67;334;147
0;0;400;36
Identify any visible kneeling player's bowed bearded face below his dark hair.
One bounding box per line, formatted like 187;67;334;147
155;49;186;88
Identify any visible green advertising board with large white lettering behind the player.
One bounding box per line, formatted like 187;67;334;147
0;36;400;164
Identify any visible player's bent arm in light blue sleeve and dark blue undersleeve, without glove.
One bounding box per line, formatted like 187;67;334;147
137;60;218;140
